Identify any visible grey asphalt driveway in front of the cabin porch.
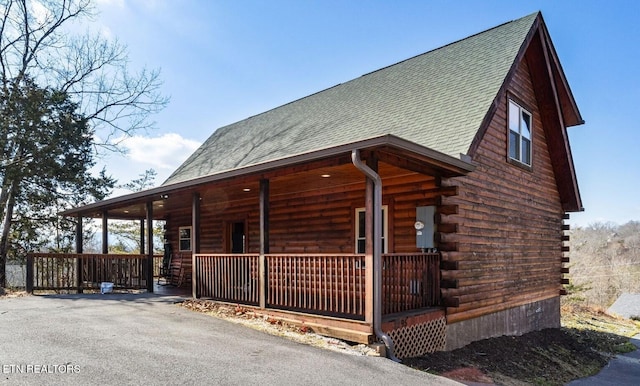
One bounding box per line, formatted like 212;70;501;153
0;294;459;385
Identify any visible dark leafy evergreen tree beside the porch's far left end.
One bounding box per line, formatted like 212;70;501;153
0;78;114;285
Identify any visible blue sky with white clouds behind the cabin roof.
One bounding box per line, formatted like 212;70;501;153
91;0;640;226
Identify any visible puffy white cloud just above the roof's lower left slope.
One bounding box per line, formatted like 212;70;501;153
121;133;200;171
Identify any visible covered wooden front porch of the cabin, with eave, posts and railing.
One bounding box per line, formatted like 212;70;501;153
55;136;472;356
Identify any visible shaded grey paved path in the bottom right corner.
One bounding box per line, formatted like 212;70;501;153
567;335;640;386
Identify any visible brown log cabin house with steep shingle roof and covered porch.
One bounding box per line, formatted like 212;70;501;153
48;13;583;358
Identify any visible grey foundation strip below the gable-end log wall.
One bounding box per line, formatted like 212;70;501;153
445;296;560;351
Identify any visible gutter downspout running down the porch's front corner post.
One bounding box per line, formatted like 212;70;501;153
351;149;400;362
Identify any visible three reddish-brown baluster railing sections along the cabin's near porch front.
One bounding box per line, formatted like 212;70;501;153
194;253;440;320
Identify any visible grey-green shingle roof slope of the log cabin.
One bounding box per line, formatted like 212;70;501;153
163;13;538;185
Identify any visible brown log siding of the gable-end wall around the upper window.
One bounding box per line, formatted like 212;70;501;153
441;56;563;323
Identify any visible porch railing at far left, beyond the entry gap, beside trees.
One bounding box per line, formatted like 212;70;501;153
26;253;155;292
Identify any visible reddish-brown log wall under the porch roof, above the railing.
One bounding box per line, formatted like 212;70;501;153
162;168;440;258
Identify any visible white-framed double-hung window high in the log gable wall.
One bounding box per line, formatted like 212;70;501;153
509;100;533;166
